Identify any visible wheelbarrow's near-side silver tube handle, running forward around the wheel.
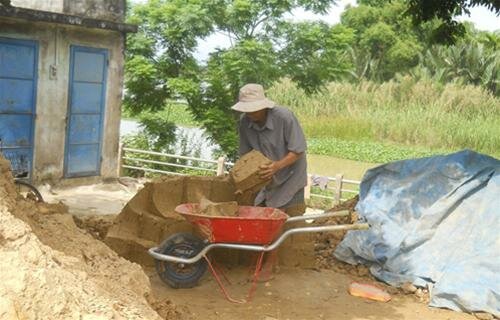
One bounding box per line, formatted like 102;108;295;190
149;223;370;264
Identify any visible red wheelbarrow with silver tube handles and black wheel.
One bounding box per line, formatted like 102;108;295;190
149;203;369;303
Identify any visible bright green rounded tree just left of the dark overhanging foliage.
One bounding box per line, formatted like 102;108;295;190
341;0;436;81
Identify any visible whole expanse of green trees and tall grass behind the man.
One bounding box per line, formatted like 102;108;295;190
124;0;500;162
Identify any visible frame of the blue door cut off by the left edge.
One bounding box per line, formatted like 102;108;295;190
0;36;39;181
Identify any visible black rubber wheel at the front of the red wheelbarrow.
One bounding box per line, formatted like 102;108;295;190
155;233;207;289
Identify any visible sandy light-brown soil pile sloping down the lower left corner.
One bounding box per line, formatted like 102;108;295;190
0;158;182;319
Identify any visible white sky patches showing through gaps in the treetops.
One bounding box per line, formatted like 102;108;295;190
132;0;500;61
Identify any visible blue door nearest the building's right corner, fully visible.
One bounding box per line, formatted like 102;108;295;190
64;46;108;177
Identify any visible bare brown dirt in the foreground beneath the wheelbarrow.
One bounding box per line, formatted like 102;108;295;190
146;268;475;320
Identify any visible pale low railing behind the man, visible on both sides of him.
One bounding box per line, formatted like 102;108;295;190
118;146;361;205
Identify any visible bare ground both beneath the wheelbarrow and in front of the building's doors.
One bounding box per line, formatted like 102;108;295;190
36;184;475;320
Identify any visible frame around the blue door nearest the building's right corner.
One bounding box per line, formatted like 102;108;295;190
63;44;109;178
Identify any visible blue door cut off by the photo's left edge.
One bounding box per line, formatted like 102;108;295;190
0;38;38;179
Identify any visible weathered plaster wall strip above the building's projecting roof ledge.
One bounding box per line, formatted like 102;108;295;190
11;0;126;22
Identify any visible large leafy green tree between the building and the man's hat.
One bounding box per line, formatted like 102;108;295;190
125;0;340;157
